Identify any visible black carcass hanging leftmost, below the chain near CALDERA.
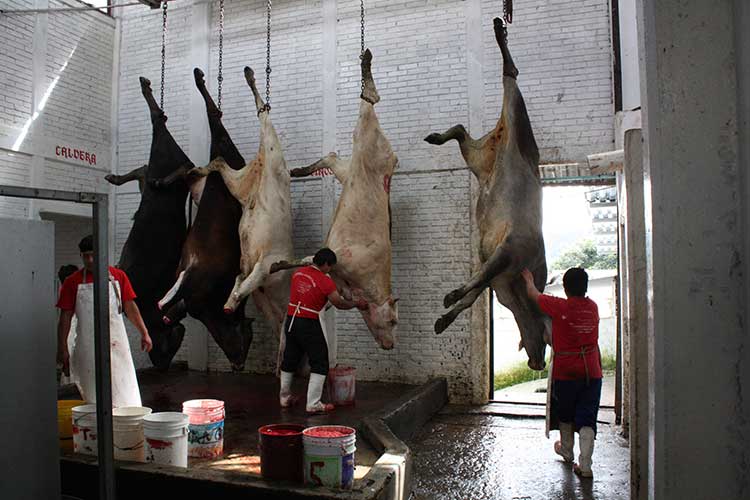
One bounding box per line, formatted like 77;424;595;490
106;77;190;369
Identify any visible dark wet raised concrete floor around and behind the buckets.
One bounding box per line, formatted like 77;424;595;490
138;369;414;479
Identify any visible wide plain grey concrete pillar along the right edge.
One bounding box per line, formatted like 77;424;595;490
637;0;750;500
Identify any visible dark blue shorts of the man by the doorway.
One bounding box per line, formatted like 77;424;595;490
552;378;602;432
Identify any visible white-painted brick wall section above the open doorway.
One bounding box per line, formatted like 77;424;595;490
482;0;614;163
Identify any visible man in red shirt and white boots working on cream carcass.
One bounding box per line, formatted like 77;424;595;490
279;248;367;413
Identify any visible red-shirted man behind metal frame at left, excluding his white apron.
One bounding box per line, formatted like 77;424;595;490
57;235;152;396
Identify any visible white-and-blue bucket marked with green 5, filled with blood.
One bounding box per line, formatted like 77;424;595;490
302;425;357;489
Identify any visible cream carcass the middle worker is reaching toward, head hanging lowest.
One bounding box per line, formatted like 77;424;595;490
291;49;398;349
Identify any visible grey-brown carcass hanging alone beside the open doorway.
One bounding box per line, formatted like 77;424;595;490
425;18;549;370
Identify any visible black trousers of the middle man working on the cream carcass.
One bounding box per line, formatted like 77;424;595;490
281;316;328;375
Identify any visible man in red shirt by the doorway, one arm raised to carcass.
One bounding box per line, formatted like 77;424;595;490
522;267;602;478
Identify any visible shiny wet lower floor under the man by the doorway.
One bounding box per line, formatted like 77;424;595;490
408;406;630;500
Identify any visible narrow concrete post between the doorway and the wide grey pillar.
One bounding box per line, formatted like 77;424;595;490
622;129;649;500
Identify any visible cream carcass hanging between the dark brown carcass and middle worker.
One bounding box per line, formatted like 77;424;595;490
188;67;293;340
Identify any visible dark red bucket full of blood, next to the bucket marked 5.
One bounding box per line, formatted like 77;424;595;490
258;424;305;483
